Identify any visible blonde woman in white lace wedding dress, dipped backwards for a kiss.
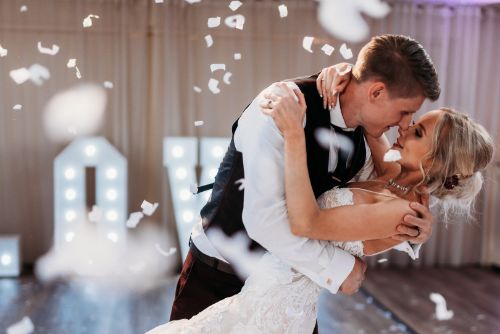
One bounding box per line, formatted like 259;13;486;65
148;79;493;334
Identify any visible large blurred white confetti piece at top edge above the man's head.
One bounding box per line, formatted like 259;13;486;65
317;0;390;43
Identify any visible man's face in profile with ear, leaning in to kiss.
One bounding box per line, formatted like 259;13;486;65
362;83;425;137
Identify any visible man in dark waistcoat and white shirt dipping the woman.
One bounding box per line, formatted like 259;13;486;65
171;35;440;332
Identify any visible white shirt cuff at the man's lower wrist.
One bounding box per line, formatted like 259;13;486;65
320;248;355;294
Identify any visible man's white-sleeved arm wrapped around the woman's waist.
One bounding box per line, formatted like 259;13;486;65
234;86;362;293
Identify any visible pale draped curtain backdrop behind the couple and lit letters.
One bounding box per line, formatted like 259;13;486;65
0;0;500;265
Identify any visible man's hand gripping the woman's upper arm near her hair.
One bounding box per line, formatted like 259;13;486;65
392;195;434;244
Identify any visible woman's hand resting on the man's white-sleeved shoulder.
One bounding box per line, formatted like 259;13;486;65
260;82;307;136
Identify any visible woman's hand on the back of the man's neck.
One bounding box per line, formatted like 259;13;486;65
316;63;352;109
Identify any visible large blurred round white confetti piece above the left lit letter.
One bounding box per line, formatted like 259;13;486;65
44;84;107;141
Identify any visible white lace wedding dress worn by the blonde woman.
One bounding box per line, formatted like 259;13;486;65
147;188;363;334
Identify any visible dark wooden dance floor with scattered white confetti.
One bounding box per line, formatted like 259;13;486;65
0;268;500;334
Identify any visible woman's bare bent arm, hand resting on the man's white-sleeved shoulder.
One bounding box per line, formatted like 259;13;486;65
262;84;414;241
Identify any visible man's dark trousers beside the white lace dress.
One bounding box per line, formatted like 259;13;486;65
170;251;318;334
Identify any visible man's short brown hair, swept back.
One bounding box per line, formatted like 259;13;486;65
353;35;441;101
